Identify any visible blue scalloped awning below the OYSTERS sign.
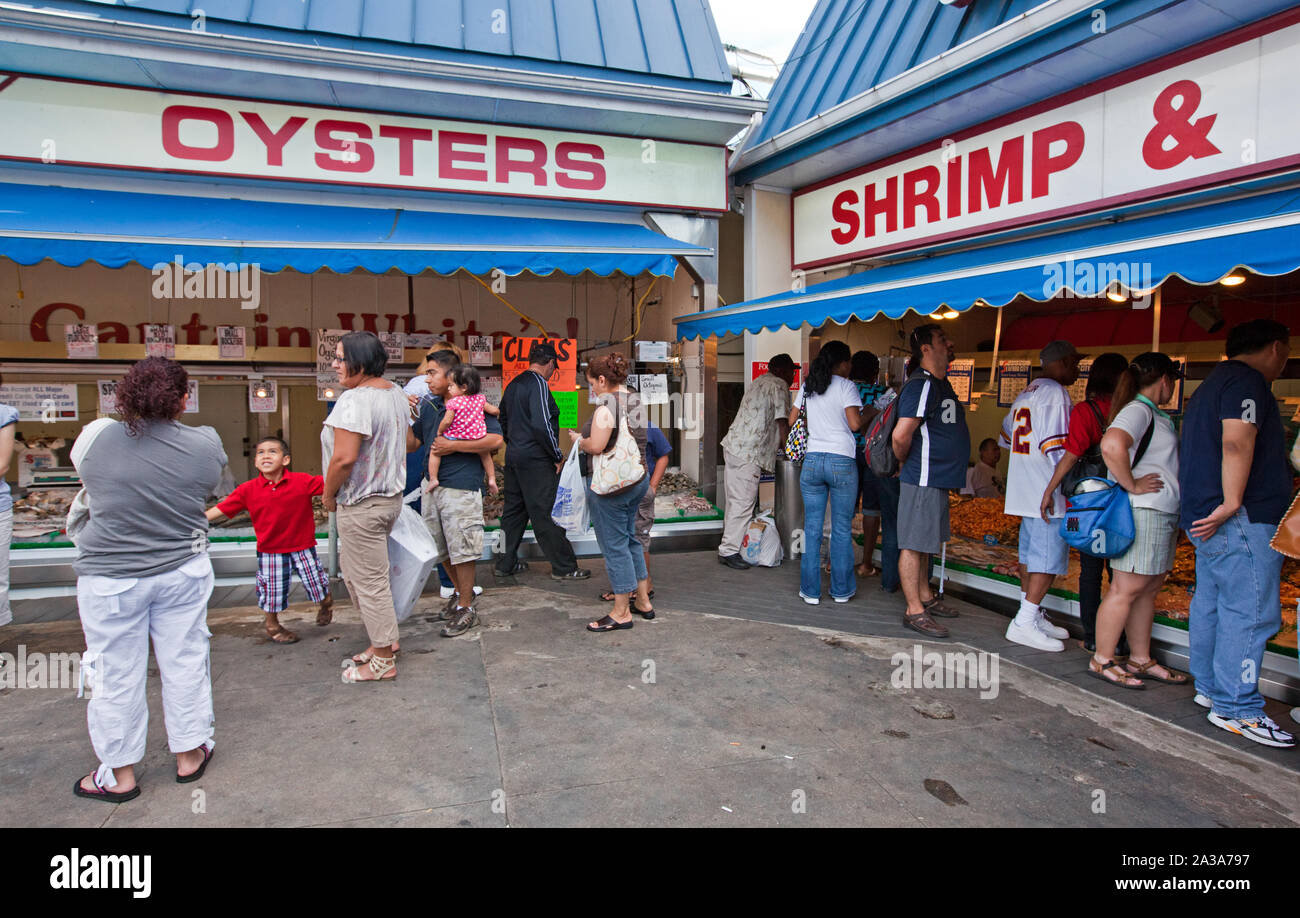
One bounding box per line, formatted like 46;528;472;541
0;183;712;277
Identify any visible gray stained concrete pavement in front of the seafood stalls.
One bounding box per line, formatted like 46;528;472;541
0;564;1300;827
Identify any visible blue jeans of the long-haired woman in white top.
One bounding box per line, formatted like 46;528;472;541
800;452;858;599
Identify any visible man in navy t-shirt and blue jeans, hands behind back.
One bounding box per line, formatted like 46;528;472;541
1178;319;1295;749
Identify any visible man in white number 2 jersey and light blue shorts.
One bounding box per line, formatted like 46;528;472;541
1000;341;1080;650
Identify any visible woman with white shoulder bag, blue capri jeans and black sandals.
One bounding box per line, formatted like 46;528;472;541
569;354;654;632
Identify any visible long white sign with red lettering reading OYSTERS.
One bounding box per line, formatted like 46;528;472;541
0;73;727;211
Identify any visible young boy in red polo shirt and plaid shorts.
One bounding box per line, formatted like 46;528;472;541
208;437;334;644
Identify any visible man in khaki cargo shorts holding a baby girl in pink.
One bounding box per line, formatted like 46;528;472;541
407;351;504;637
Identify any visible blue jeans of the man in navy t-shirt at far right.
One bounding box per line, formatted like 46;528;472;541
1187;510;1283;720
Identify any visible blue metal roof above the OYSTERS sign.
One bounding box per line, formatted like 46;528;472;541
48;0;732;92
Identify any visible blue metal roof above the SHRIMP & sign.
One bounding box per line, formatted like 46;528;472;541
746;0;1043;146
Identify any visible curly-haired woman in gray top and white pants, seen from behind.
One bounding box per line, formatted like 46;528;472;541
69;358;226;804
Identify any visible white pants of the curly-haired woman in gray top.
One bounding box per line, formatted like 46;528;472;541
77;553;213;788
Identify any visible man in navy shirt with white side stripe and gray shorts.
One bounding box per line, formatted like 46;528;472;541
893;324;971;637
